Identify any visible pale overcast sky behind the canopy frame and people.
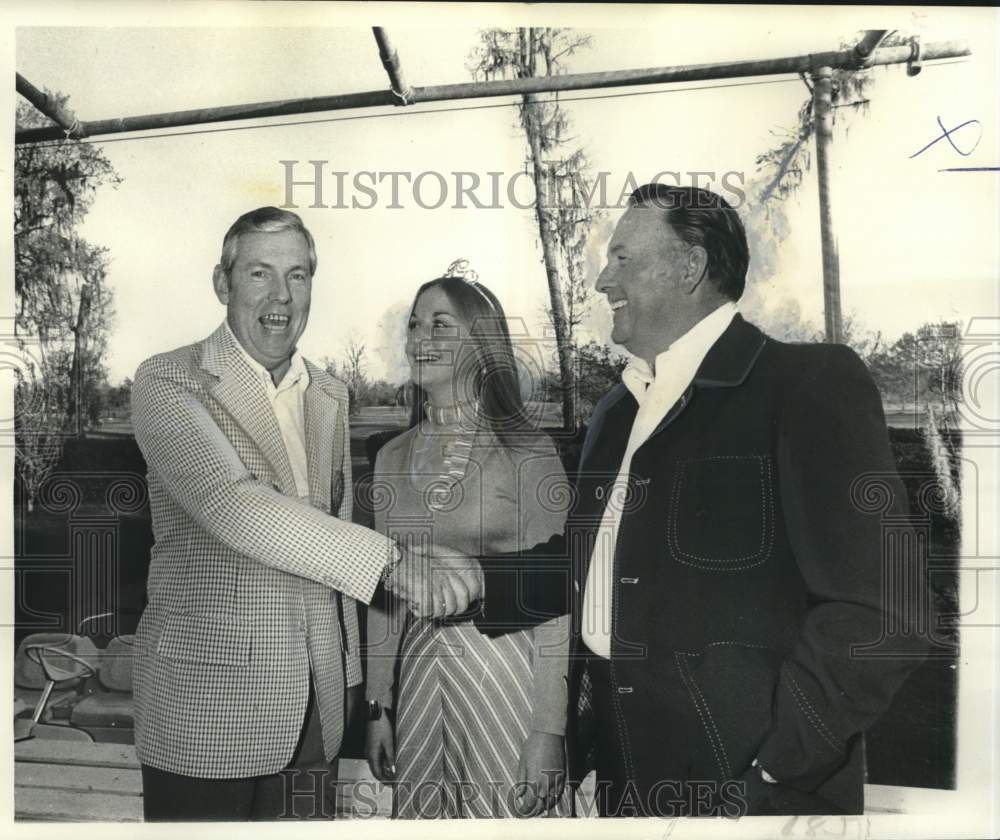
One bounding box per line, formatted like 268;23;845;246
9;3;1000;382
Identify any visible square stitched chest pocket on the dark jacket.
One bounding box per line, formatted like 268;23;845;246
667;455;774;572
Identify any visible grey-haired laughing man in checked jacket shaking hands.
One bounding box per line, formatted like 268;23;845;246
132;207;458;820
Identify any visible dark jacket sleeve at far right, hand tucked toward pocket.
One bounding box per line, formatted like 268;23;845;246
757;346;926;791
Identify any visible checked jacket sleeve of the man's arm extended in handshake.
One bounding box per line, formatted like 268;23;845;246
132;357;397;603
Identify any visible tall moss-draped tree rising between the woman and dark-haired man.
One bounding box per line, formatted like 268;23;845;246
469;27;596;429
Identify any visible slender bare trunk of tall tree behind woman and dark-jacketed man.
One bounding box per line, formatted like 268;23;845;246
524;94;576;432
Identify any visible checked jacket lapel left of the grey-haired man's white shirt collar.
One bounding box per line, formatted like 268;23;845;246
202;325;295;495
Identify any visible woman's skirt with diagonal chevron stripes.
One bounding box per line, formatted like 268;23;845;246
394;621;571;819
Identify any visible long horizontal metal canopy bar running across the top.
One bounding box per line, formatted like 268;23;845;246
14;41;971;144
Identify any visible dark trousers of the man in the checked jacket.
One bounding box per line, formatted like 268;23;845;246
142;680;337;822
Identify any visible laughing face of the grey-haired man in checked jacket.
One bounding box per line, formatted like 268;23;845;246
213;230;312;383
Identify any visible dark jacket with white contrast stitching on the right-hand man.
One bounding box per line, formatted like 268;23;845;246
476;315;925;813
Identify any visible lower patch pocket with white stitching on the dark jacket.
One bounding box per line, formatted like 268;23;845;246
674;642;781;779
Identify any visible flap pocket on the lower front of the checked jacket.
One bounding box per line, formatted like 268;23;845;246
156;613;251;668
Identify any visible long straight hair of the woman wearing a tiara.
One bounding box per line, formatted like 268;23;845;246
410;277;532;446
